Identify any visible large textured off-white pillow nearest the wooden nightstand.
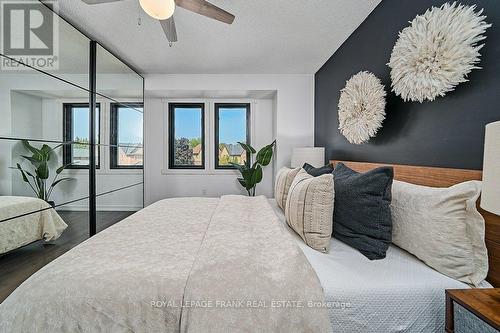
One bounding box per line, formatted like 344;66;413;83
391;180;488;286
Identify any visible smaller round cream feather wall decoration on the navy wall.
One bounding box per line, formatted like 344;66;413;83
339;71;385;144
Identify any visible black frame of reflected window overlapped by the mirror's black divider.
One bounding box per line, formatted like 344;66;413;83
63;103;102;170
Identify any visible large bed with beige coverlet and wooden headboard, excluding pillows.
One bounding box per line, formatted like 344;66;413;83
0;162;500;332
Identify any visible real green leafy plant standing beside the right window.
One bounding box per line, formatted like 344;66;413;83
230;140;276;196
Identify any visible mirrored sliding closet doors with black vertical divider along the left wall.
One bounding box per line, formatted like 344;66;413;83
0;1;144;302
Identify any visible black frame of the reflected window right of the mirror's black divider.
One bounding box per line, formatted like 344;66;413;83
109;102;144;170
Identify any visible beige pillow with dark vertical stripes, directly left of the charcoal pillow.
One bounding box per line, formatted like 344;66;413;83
285;170;334;253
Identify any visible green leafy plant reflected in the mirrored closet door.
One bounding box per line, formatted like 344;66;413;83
11;140;73;207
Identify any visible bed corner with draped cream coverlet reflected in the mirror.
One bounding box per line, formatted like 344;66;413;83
0;196;68;254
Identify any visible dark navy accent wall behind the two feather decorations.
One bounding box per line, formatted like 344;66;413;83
315;0;500;169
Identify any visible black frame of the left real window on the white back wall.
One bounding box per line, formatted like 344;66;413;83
168;103;206;170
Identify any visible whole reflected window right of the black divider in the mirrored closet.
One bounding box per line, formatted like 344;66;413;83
109;103;144;169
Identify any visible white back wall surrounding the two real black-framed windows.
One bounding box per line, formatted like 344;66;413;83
144;75;314;205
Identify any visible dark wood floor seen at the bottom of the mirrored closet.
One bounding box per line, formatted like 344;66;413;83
0;211;133;303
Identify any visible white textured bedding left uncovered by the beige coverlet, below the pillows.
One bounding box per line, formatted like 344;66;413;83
269;199;491;333
